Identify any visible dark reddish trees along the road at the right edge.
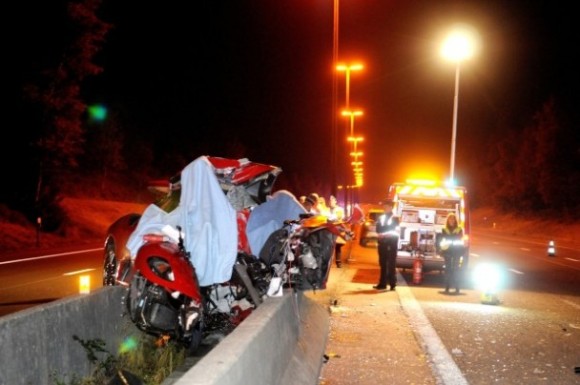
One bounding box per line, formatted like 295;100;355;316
476;97;580;221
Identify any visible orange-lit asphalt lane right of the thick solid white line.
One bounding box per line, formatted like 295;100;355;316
422;232;580;384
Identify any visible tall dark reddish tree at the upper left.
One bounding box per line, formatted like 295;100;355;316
25;0;111;226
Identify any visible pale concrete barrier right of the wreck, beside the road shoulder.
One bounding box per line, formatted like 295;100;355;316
163;291;330;385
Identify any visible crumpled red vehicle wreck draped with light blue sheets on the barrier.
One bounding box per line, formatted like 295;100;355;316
103;156;344;344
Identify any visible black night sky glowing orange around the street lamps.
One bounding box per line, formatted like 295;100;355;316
10;0;580;201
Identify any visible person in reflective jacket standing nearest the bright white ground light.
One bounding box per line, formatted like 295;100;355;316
439;213;465;294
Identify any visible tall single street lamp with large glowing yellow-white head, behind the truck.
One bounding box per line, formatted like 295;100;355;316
441;26;477;184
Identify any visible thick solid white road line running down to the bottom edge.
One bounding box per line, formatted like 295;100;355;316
397;272;469;385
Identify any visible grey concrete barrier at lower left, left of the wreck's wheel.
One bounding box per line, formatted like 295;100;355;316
0;286;141;385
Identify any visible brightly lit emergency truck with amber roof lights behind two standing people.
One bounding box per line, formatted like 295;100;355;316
388;181;470;271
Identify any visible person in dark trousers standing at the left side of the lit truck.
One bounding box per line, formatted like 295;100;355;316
373;200;400;290
